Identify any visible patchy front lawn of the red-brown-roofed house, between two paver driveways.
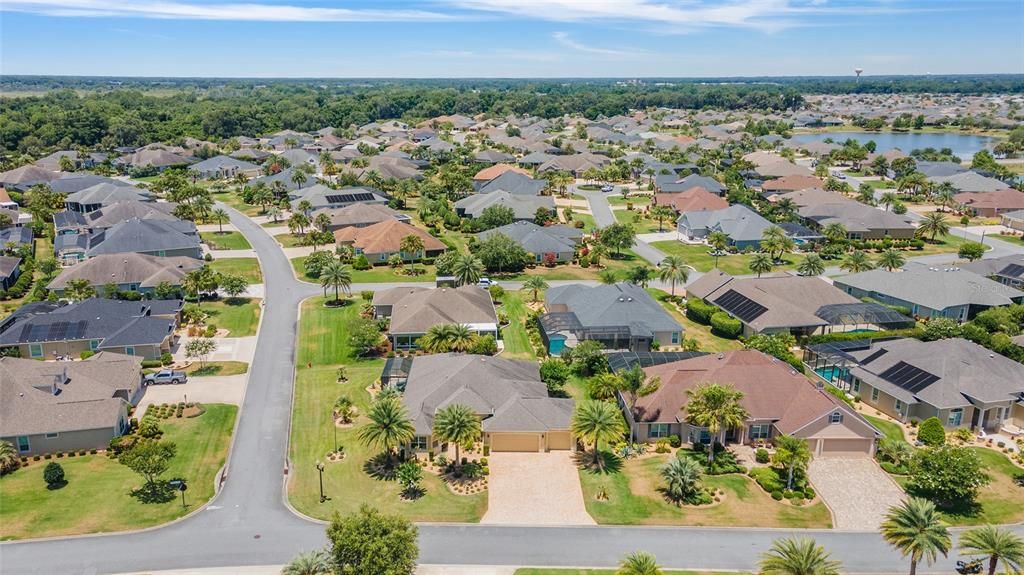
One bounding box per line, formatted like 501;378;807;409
580;454;831;528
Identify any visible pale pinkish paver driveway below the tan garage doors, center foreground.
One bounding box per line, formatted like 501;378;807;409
480;451;596;525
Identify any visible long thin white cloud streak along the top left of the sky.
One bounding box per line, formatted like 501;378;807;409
0;0;464;21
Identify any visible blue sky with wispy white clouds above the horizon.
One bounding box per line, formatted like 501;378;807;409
0;0;1024;78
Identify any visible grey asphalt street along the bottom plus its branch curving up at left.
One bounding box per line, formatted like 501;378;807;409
0;203;1024;575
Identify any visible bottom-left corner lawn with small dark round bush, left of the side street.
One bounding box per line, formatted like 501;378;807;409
0;404;238;539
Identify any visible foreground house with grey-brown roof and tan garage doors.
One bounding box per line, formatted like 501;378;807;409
401;353;575;452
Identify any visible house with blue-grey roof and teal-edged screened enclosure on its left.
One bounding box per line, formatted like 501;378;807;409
540;282;683;355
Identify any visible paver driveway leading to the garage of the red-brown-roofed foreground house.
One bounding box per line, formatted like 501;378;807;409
808;457;905;531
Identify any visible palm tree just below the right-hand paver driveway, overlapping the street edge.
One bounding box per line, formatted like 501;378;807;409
882;497;952;575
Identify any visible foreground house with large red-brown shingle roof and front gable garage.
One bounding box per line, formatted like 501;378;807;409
618;350;882;457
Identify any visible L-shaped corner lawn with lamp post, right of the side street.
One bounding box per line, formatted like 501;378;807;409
288;298;487;522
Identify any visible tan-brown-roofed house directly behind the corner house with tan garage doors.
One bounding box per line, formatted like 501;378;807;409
374;285;500;349
